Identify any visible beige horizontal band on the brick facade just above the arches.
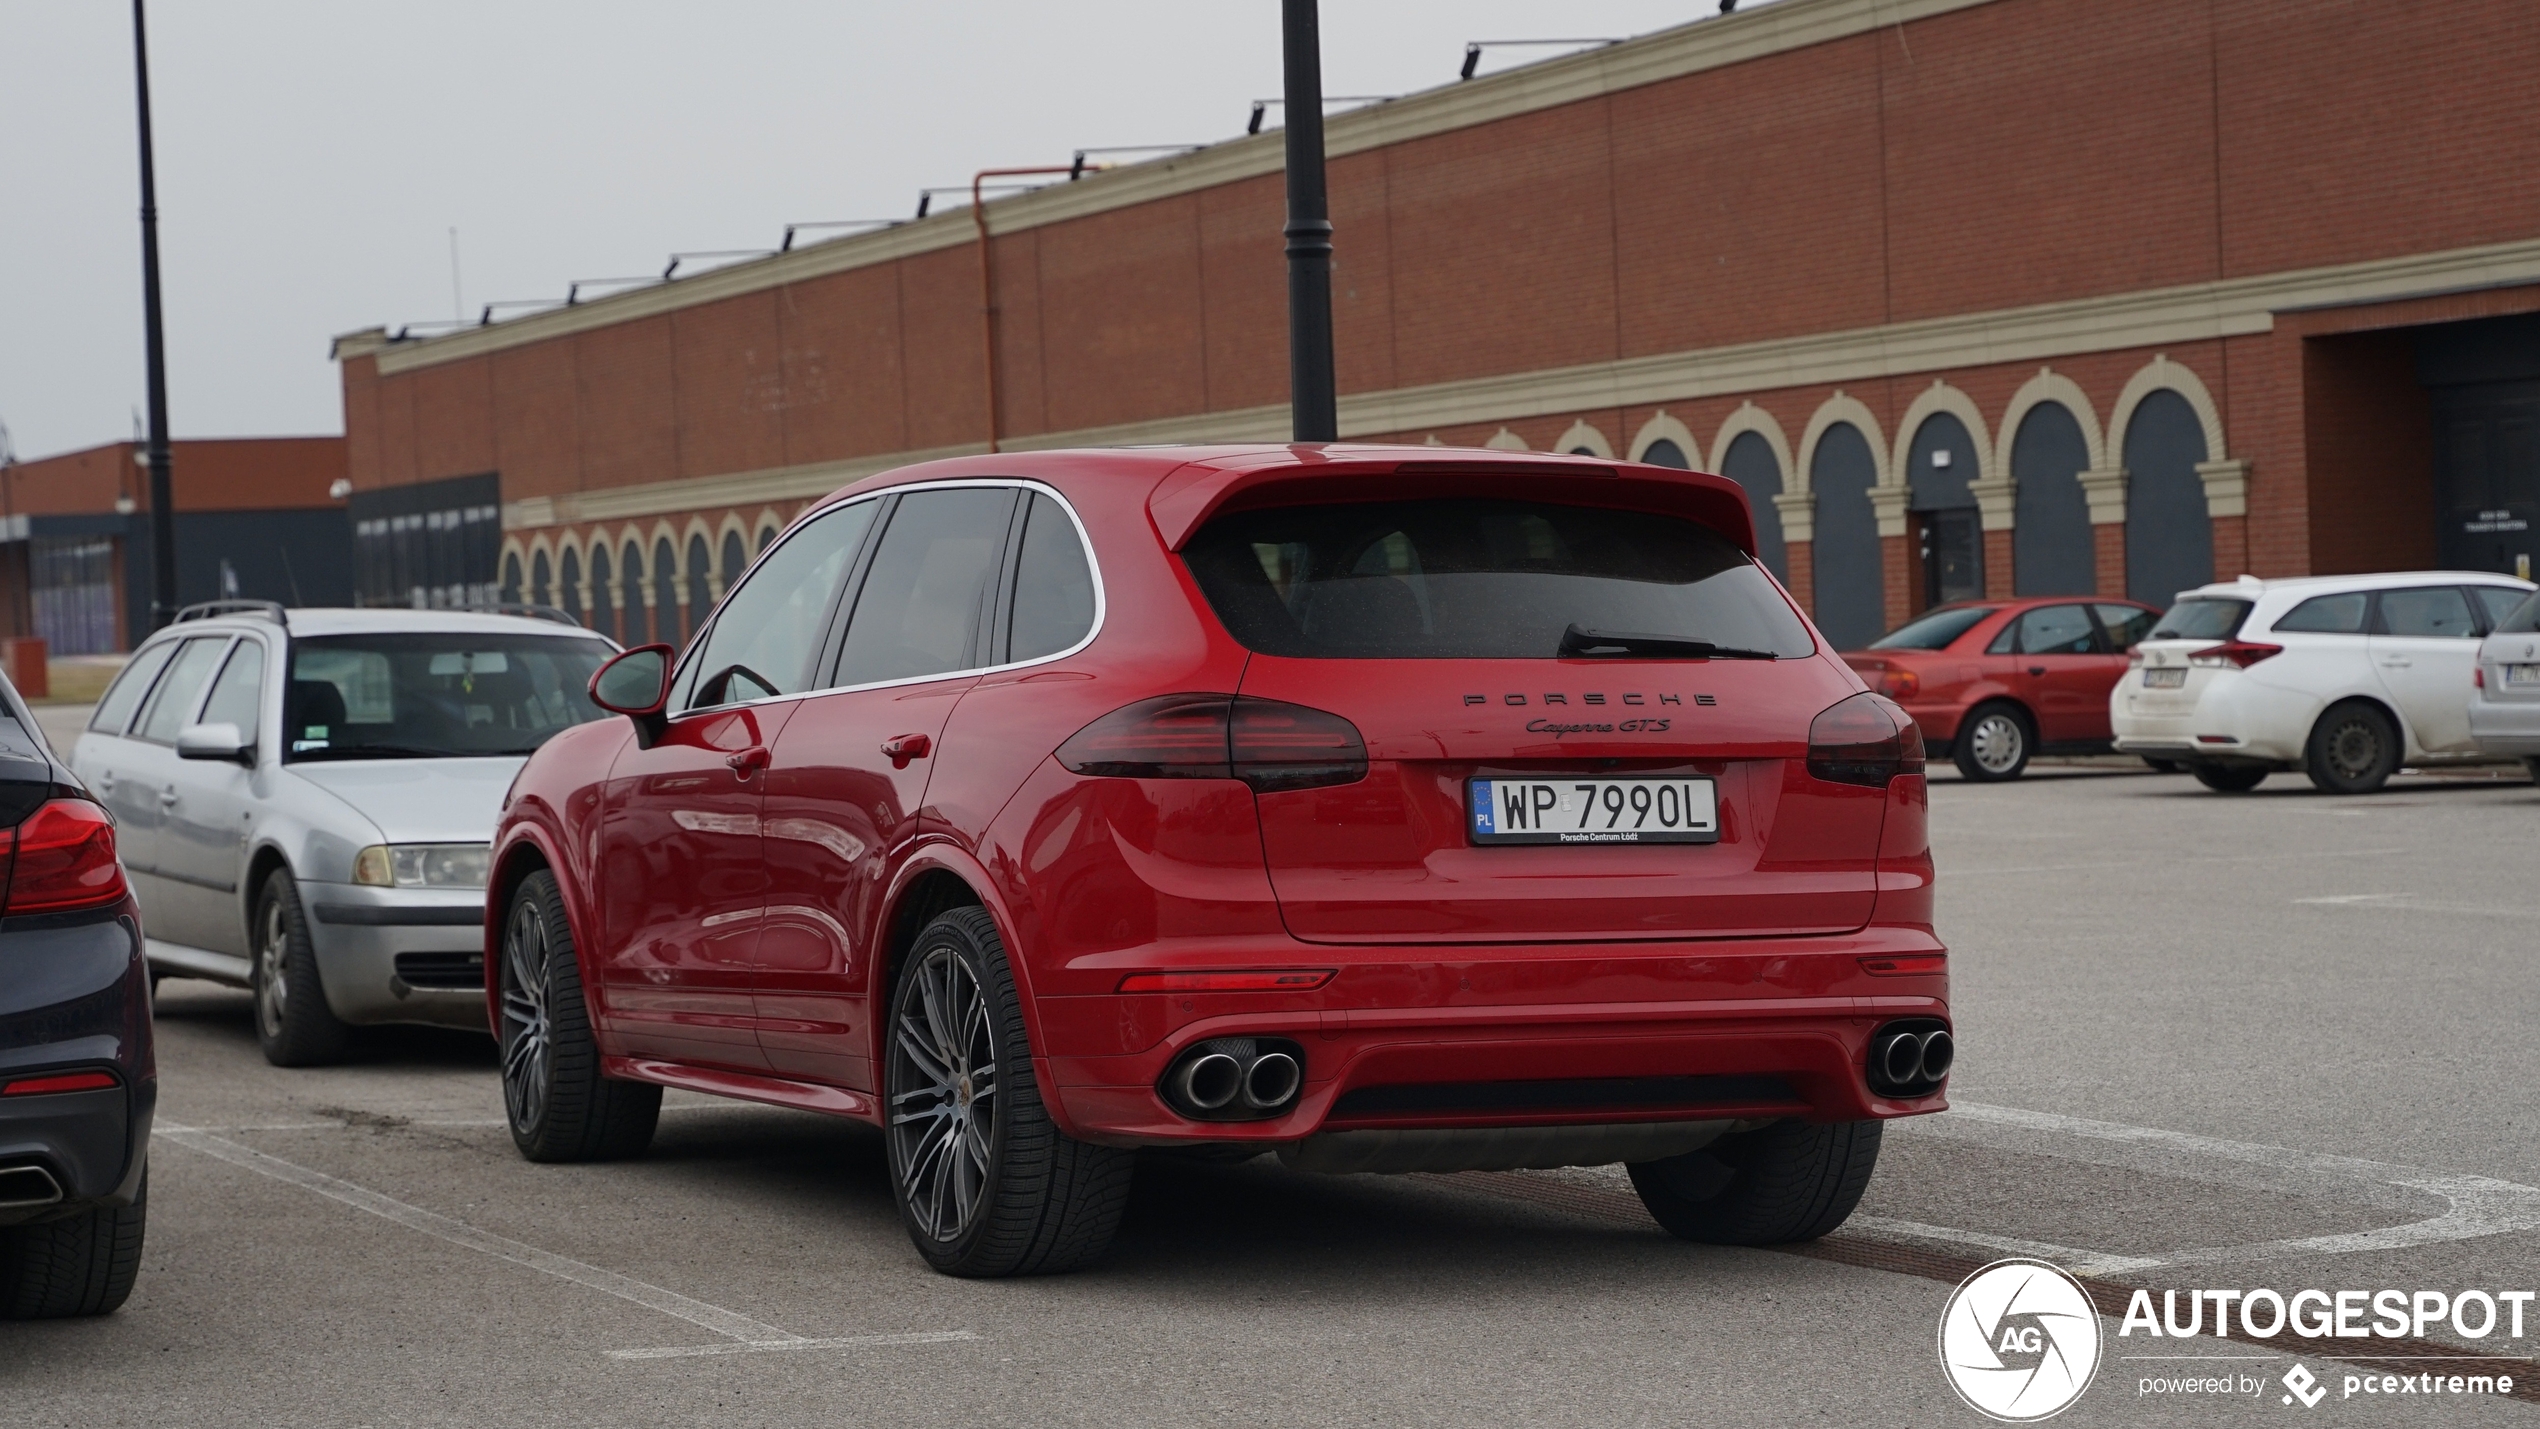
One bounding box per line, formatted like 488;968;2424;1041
503;241;2540;528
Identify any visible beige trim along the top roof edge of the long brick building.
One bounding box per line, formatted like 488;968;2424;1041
358;0;1991;376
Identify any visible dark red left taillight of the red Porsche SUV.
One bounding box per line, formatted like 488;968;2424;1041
1059;695;1367;792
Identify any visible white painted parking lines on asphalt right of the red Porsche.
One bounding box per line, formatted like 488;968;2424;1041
1899;1102;2540;1274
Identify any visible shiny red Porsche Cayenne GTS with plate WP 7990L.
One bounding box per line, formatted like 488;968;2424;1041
488;447;1951;1274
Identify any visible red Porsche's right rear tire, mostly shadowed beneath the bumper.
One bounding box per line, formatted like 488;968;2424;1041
1626;1122;1882;1246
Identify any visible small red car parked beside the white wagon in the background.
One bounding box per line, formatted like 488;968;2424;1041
1844;596;2162;782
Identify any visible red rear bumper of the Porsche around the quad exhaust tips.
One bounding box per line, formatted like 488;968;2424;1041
1041;929;1948;1145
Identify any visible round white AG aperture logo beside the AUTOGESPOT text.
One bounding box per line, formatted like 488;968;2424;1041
1941;1259;2098;1424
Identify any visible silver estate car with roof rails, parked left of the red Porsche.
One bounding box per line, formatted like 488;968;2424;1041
71;602;617;1066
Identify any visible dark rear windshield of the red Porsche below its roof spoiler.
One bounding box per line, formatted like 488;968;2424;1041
1184;497;1816;660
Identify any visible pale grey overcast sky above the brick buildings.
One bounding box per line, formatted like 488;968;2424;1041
0;0;1767;459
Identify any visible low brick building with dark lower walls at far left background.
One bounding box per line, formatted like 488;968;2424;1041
0;437;353;655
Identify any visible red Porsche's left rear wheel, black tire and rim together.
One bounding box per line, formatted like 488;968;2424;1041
881;909;1138;1277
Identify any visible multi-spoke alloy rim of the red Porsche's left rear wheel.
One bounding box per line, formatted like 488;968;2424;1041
886;947;996;1244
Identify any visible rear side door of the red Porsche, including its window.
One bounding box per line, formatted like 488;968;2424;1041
754;485;1021;1089
